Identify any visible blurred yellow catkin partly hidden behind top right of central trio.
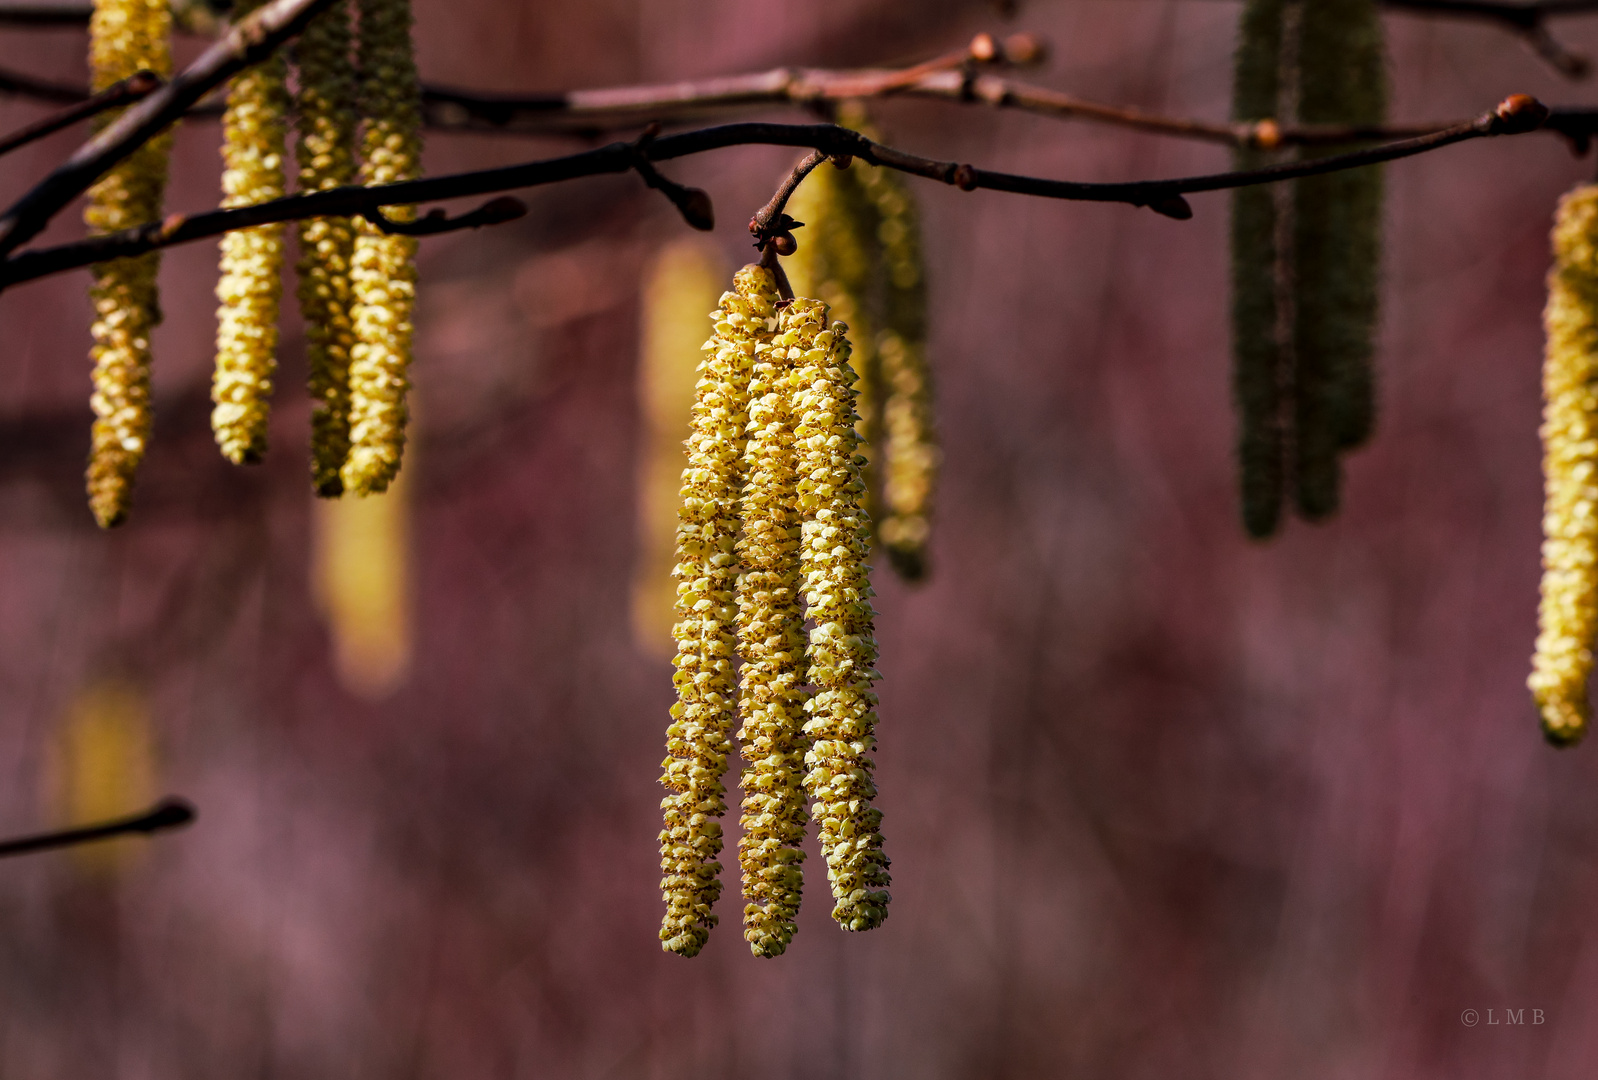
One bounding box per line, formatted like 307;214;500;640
783;155;884;508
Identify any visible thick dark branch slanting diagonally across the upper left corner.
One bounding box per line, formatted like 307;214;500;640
0;0;332;256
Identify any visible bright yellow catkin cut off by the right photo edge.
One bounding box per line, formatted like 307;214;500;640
1528;184;1598;746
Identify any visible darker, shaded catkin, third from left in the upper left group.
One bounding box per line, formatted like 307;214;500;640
294;0;355;498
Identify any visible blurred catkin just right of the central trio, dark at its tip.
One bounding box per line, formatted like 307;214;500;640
862;168;940;582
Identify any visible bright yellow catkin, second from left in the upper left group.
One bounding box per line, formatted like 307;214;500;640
211;0;289;465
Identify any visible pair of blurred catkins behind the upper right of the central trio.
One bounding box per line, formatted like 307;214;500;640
785;119;940;580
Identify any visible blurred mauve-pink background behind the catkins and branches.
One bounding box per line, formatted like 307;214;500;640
0;0;1598;1080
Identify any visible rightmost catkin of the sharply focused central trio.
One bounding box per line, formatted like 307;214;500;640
792;299;888;930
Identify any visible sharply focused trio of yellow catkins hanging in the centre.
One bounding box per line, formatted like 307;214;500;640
660;265;888;957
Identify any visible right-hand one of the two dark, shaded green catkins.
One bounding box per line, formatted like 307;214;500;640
1293;0;1387;521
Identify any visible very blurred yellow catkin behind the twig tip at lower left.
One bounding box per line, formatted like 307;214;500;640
50;679;155;874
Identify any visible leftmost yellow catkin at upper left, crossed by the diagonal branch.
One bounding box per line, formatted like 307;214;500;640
83;0;173;529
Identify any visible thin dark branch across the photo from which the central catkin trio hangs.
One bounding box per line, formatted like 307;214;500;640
0;94;1548;286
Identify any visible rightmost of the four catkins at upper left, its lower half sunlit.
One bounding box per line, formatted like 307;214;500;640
342;0;422;495
